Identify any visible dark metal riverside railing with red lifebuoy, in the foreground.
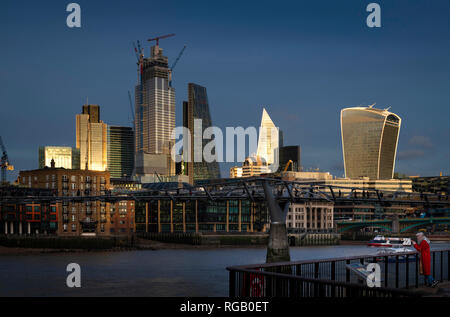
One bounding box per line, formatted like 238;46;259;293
227;248;450;297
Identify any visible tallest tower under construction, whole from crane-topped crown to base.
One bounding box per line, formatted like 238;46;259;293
135;37;175;176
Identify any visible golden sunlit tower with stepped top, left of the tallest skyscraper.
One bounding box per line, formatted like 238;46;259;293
76;105;107;171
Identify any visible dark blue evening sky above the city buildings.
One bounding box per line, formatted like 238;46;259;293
0;0;450;179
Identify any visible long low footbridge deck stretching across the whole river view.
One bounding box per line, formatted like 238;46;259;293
0;177;450;205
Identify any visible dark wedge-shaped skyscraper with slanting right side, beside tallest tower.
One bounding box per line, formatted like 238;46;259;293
183;83;220;184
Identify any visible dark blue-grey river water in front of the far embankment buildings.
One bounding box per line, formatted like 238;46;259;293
0;243;450;296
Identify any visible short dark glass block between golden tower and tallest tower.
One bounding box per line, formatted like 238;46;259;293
108;126;134;178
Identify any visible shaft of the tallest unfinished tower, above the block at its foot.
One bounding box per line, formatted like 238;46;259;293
135;45;175;154
